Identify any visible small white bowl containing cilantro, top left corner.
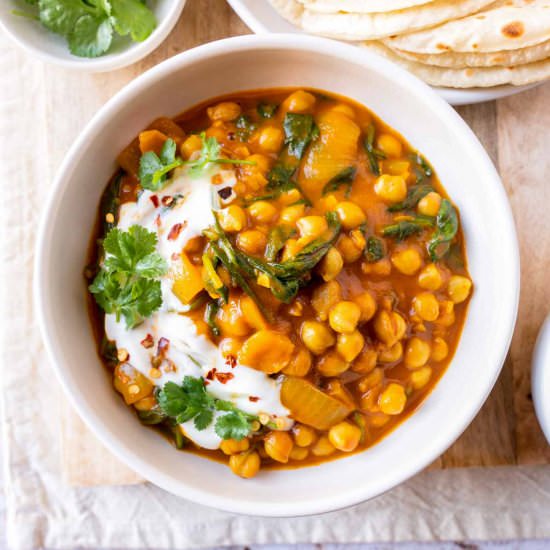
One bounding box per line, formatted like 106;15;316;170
0;0;186;72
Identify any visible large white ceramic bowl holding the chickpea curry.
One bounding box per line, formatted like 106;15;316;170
35;35;519;516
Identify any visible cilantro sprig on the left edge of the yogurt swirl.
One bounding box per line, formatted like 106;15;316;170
89;225;168;329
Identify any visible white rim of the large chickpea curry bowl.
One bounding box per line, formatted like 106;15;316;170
34;34;520;517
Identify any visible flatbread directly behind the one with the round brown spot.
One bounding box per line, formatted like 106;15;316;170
301;0;498;41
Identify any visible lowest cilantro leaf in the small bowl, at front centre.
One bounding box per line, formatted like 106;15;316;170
67;14;113;57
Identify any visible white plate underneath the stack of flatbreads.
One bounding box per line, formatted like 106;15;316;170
227;0;538;105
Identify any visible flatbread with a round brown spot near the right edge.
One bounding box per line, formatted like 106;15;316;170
385;0;550;54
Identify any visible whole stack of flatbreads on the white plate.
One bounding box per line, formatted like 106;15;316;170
270;0;550;88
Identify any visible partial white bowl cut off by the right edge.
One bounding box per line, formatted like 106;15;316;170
531;315;550;445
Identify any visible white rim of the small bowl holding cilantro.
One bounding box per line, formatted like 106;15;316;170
0;0;187;73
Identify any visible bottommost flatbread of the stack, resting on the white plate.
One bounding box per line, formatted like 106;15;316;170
361;42;550;88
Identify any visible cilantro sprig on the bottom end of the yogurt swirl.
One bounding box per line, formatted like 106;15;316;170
157;376;257;441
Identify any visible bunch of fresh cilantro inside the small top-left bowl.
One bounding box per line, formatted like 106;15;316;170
16;0;157;57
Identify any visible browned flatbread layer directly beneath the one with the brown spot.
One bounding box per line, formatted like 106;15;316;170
391;40;550;69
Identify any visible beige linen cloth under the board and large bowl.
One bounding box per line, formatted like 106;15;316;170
0;29;550;550
